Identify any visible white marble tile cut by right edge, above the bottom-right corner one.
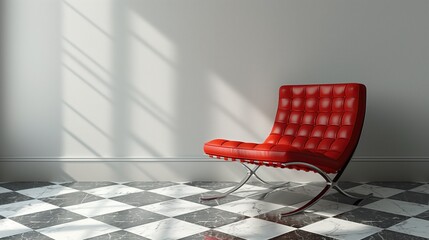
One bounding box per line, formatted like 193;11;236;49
364;199;429;217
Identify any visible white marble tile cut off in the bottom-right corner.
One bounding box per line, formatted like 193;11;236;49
389;218;429;238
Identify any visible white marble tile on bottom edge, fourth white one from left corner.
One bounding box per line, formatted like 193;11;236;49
215;218;295;240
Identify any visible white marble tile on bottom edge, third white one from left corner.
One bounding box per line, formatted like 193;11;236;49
126;218;209;240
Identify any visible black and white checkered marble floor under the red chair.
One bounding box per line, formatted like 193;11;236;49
0;182;429;240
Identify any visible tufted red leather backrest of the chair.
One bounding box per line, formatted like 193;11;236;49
265;83;366;161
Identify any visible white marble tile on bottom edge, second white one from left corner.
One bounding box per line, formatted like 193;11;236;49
38;218;120;240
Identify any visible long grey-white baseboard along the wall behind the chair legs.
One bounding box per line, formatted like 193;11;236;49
0;158;429;182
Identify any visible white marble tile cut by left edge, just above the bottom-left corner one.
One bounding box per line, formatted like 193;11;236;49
0;199;58;218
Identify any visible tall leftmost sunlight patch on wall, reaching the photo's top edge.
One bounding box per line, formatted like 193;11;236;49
61;1;113;157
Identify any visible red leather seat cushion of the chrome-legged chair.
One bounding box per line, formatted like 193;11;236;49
204;139;342;173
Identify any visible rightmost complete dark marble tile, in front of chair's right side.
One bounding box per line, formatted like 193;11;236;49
335;208;409;228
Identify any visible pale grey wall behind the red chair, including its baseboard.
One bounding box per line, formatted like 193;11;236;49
0;0;429;181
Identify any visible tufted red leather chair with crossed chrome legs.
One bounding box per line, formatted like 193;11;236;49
202;83;366;215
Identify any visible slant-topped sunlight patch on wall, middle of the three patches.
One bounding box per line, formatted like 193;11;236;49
128;9;178;157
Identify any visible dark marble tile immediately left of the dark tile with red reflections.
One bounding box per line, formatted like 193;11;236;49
175;208;246;228
